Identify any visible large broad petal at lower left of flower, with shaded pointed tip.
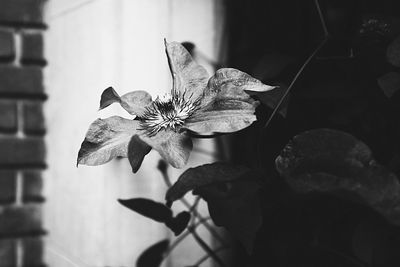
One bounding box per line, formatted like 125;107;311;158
77;116;139;166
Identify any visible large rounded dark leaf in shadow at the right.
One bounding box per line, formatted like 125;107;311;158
276;129;400;225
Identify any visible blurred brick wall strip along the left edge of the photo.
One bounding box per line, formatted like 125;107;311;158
0;0;46;267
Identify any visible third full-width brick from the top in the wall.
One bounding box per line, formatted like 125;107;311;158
0;137;45;166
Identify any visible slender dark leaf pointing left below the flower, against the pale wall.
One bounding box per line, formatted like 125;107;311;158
118;198;172;223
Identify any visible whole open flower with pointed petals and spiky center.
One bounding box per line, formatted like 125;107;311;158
77;41;275;172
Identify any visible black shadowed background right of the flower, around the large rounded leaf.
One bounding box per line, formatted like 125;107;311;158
226;0;400;267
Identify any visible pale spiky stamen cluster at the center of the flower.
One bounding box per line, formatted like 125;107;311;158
140;91;199;136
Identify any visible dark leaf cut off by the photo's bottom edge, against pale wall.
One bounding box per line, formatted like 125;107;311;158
136;239;169;267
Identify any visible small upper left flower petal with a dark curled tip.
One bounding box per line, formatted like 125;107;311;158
100;87;152;116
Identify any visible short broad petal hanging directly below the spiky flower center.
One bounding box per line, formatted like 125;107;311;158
140;130;193;169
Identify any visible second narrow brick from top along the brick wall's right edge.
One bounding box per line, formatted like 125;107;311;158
23;102;46;134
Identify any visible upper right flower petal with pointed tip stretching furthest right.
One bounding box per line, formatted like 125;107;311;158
201;68;276;107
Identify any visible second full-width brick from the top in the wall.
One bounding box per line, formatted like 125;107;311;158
0;66;44;95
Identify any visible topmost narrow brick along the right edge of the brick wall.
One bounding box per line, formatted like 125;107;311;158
22;33;46;65
